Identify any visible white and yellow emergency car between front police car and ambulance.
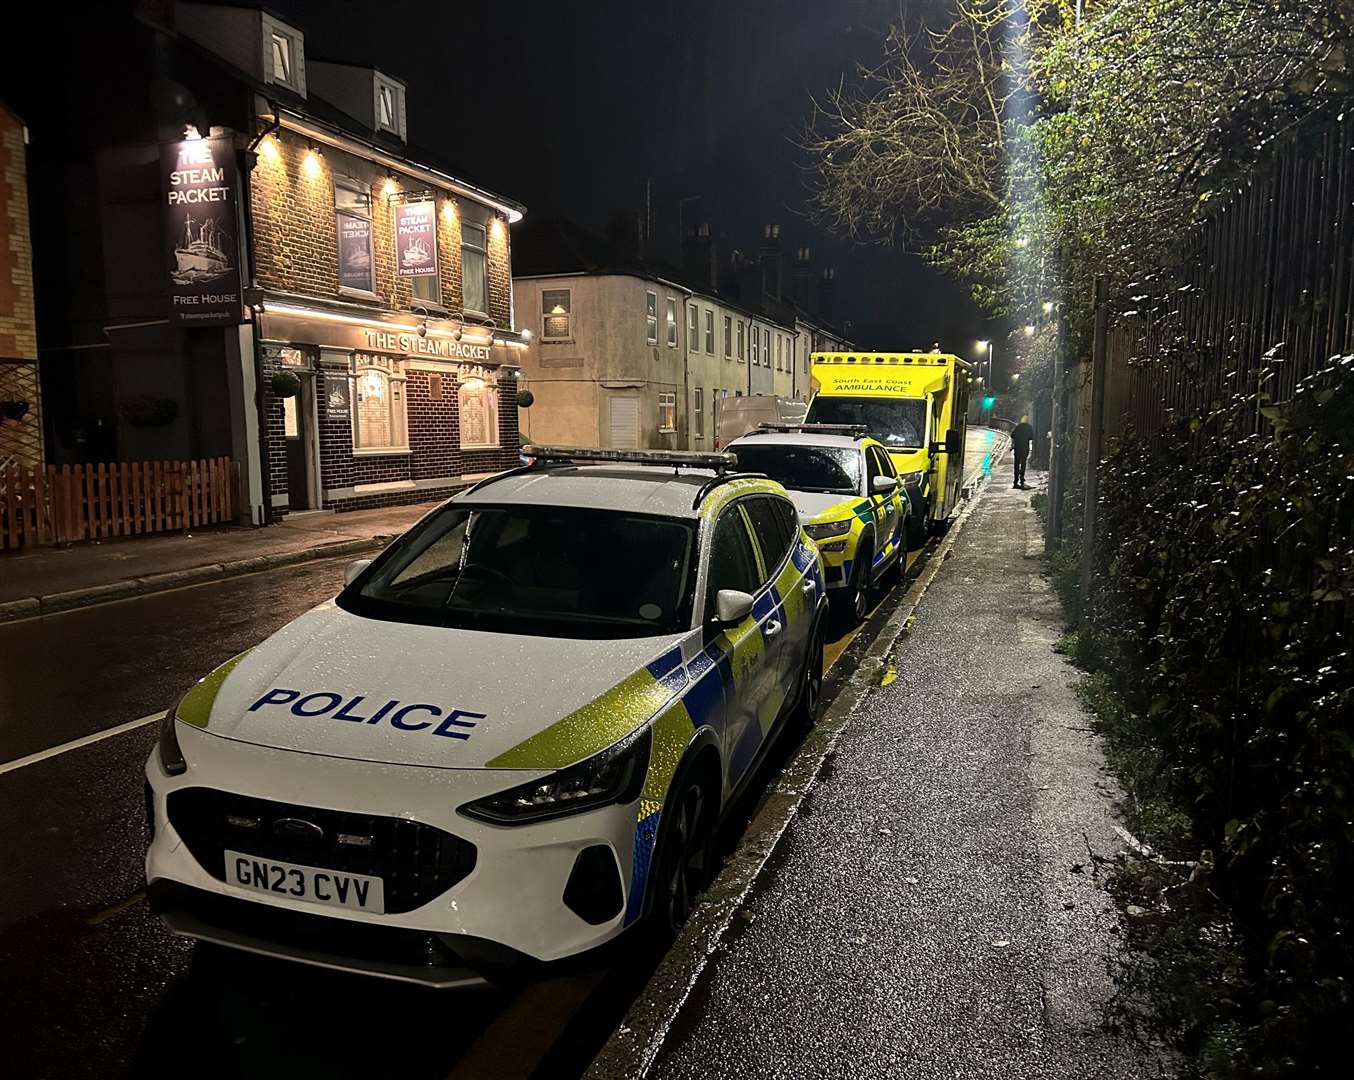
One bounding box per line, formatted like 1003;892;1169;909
728;424;909;623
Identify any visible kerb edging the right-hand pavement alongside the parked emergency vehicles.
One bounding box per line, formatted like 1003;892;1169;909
584;457;999;1080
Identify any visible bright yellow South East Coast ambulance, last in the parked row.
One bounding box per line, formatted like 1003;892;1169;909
808;352;974;548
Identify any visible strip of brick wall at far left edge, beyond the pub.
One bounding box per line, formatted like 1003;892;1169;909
0;106;42;466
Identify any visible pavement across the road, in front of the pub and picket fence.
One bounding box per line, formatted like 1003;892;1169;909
0;502;437;623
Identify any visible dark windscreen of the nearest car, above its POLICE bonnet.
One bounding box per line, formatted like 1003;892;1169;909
339;506;695;637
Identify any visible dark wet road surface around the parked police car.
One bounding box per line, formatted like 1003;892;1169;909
0;432;988;1080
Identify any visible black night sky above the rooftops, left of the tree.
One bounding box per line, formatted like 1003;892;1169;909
268;0;982;355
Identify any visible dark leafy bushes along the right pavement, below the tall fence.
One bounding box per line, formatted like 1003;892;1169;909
1055;357;1354;1077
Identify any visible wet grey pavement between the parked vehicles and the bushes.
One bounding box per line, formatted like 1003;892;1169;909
614;474;1159;1080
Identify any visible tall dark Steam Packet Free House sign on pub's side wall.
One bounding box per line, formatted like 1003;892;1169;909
160;138;242;326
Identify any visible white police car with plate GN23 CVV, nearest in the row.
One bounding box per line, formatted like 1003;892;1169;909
146;448;826;987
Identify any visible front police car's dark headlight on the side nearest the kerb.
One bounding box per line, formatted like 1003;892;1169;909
460;724;653;826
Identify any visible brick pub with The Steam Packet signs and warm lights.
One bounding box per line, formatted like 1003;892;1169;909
20;0;529;524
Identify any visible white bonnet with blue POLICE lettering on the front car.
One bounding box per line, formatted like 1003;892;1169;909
197;602;680;769
